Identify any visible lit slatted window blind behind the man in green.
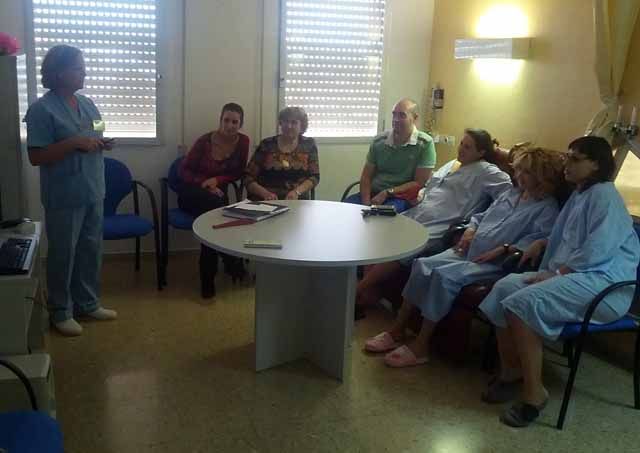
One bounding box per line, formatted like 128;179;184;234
281;0;385;137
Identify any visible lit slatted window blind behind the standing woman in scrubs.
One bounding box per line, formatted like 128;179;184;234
32;0;157;138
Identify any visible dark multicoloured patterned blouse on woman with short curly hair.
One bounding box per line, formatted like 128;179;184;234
244;136;320;199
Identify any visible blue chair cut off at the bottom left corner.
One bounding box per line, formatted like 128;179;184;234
0;359;64;453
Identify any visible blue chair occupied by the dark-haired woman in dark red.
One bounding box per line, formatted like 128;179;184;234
160;157;242;286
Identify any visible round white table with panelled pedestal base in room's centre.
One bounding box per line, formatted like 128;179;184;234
193;200;428;380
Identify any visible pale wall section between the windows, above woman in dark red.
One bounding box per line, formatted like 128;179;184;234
184;0;262;145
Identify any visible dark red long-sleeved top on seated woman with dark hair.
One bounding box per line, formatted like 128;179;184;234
179;132;249;187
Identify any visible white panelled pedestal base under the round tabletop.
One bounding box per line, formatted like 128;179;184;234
255;262;356;380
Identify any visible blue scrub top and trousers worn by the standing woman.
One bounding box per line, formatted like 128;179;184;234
25;91;105;323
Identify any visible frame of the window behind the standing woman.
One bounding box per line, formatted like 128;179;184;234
23;0;168;147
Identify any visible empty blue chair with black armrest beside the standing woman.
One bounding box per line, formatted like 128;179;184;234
103;158;162;290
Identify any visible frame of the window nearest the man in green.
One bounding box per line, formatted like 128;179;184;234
276;0;391;145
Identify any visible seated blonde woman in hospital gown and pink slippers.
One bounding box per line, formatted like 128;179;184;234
365;147;562;367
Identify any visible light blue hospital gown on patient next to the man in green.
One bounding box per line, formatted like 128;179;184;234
401;160;512;256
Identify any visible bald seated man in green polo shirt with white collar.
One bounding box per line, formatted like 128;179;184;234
345;99;436;212
